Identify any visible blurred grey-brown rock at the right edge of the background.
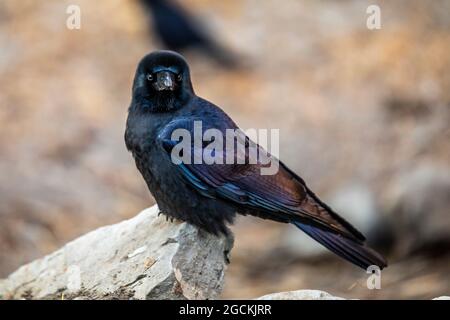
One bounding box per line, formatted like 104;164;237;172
388;164;450;255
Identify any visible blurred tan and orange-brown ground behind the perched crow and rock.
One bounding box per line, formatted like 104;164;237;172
0;0;450;299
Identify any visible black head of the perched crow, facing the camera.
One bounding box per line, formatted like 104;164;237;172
132;51;194;112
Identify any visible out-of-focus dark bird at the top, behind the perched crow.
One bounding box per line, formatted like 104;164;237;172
141;0;240;68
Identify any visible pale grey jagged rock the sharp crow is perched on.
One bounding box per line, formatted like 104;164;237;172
0;206;233;299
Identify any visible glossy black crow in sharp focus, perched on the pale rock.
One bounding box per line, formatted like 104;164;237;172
124;50;387;269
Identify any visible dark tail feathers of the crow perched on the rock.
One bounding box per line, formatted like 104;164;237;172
293;221;387;270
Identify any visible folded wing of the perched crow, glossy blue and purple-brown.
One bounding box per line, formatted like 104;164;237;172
158;118;364;242
